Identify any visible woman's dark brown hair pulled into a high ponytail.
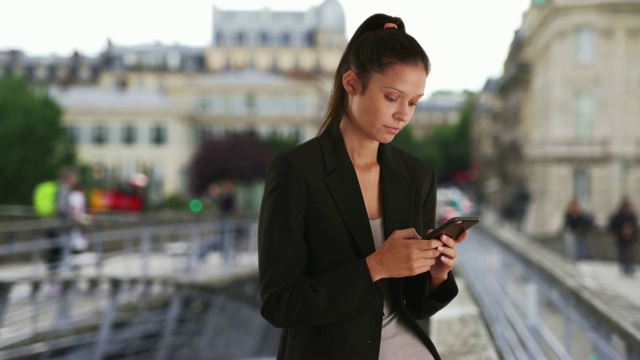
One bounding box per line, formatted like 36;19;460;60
318;14;431;134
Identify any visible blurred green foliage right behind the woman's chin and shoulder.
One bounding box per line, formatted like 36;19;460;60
393;96;473;182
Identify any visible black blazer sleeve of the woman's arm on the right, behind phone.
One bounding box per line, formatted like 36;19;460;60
403;168;458;319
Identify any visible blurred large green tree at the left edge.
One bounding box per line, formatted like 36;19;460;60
0;77;76;205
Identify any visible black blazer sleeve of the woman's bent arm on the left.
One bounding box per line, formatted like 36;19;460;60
258;155;382;327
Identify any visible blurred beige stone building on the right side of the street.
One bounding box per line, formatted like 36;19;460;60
475;0;640;234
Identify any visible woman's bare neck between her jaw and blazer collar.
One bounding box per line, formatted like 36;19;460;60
339;116;380;167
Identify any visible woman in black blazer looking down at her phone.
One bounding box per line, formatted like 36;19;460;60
258;14;467;359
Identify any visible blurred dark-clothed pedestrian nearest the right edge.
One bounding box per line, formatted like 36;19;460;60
608;198;638;276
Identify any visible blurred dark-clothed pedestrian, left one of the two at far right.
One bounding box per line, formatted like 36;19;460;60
562;198;593;261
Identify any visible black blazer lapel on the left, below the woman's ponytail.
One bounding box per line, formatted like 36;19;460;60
319;126;375;256
